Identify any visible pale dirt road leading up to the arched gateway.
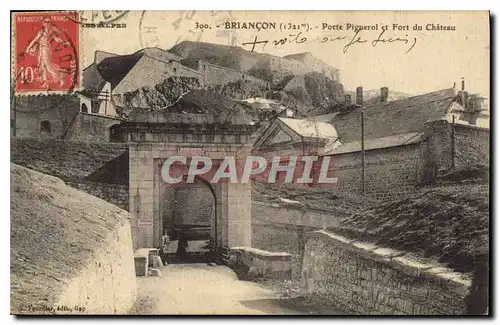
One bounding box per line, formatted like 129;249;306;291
131;264;316;315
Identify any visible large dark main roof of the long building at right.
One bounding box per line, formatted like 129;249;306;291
331;88;456;143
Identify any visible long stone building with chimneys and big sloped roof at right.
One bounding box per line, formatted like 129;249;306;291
256;83;490;198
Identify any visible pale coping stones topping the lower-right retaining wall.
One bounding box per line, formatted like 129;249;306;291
306;230;472;295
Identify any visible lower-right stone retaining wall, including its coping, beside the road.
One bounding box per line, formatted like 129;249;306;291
301;231;471;315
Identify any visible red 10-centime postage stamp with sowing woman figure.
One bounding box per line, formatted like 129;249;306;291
13;12;80;93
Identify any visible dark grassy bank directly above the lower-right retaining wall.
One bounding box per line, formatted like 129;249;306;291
335;190;489;272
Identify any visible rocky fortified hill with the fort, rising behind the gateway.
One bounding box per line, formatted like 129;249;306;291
90;41;344;117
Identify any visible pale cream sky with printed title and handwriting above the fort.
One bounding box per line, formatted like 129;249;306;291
80;11;490;97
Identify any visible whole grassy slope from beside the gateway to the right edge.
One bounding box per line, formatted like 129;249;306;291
252;178;489;272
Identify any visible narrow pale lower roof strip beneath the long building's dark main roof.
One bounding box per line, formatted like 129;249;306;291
324;132;424;155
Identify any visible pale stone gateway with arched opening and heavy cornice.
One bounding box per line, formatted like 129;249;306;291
121;113;257;249
